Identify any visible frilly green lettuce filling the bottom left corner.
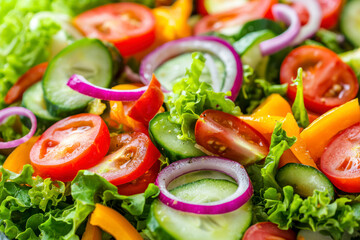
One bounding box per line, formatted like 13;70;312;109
0;165;159;239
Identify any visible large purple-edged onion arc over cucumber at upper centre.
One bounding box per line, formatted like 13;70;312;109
140;36;243;100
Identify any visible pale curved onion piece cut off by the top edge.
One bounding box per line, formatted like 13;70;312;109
291;0;322;46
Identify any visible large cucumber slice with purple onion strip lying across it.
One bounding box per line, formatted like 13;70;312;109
43;38;113;117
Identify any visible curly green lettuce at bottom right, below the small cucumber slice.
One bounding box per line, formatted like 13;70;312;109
264;186;360;240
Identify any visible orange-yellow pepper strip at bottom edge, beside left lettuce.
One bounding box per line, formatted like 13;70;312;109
90;203;143;240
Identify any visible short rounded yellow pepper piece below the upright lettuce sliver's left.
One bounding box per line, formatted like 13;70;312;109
252;93;292;117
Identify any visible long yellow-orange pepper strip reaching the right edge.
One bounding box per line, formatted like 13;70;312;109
300;99;360;161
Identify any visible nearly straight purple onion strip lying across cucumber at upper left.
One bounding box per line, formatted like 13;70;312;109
66;74;147;101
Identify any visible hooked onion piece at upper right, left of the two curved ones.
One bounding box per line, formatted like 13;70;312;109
259;4;301;56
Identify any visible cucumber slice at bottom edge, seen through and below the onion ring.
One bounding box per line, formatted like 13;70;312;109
147;179;252;240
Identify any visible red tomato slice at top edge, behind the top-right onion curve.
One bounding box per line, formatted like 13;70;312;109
292;0;344;29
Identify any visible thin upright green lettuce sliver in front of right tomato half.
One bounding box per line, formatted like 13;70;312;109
291;68;309;128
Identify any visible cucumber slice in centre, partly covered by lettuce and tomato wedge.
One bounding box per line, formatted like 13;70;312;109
149;112;205;162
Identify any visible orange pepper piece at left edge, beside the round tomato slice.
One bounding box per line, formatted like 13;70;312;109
3;136;40;173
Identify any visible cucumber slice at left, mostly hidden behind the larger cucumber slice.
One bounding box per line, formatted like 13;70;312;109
21;82;61;130
